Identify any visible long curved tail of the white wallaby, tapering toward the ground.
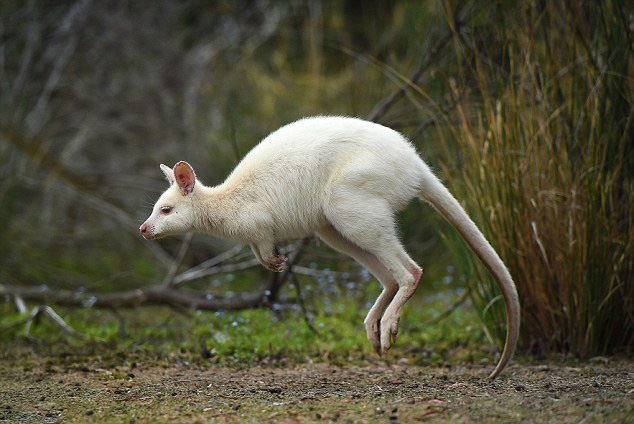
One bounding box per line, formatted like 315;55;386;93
419;169;520;379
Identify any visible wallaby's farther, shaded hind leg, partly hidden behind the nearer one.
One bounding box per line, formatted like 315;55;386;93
317;225;398;354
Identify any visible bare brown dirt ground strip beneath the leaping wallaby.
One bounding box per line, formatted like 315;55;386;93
0;360;634;424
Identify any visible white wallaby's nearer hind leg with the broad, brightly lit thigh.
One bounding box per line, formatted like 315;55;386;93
326;194;422;352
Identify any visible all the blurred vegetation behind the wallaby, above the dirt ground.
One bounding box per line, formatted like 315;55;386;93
0;0;634;364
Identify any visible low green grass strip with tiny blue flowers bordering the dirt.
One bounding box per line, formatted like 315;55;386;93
0;288;494;366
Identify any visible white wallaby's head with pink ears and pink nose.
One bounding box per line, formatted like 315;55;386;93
139;162;201;240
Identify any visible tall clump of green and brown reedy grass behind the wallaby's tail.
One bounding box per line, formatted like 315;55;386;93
436;0;634;356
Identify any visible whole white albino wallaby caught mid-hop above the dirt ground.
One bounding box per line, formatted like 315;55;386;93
140;117;520;378
